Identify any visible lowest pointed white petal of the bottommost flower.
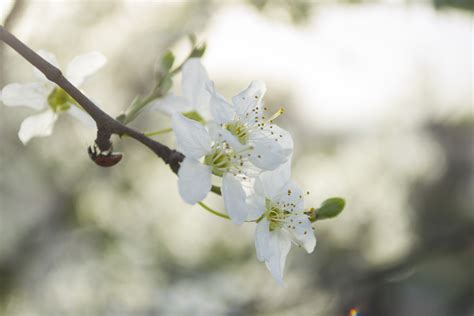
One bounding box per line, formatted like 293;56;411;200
265;229;291;285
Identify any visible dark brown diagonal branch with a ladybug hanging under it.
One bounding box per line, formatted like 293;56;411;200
0;25;184;173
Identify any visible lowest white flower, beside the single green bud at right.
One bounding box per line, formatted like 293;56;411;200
252;164;316;284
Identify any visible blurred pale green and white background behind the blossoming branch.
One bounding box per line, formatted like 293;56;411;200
0;0;474;316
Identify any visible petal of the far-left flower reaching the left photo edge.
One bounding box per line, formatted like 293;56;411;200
1;83;49;110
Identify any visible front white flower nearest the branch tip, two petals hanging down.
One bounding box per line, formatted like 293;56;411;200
172;113;257;224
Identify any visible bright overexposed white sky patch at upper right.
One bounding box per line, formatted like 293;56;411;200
205;5;473;130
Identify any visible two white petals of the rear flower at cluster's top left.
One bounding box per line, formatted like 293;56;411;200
150;58;210;118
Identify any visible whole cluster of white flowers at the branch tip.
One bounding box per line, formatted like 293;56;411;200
152;59;316;283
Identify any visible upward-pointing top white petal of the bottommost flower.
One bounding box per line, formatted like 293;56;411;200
255;162;291;200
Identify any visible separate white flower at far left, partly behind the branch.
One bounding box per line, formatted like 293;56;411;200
1;51;106;144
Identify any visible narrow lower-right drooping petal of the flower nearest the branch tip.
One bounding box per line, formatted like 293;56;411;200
222;174;248;225
